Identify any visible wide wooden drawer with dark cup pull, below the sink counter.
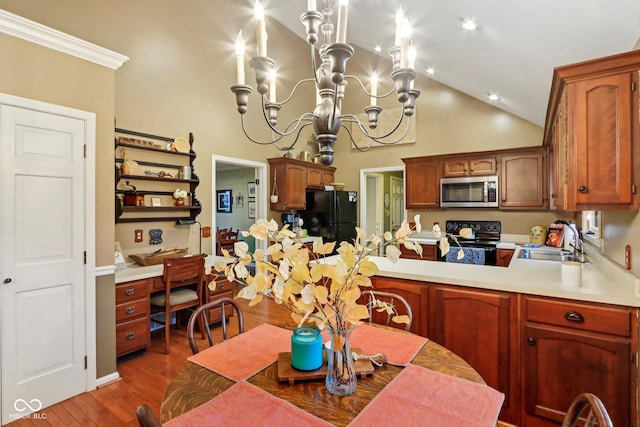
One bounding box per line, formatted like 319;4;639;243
525;297;632;337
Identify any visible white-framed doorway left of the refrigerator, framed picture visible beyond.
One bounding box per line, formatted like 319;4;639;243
208;154;267;255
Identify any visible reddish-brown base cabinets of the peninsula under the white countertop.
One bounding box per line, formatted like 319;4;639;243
372;276;638;427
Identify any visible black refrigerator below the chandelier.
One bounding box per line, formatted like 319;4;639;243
298;190;358;248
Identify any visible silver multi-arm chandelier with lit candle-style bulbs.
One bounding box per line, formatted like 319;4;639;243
231;0;420;165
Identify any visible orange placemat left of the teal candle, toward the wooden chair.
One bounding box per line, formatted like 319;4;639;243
188;323;292;381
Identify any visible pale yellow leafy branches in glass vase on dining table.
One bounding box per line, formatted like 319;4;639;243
209;216;470;395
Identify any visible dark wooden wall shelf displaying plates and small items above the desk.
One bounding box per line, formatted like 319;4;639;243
115;128;202;222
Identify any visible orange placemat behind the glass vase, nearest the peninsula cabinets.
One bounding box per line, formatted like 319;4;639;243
323;324;428;366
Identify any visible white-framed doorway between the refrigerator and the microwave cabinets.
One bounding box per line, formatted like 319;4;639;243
360;166;407;252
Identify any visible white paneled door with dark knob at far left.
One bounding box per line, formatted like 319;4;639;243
0;100;88;424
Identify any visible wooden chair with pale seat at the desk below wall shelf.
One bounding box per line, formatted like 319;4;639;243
151;255;204;354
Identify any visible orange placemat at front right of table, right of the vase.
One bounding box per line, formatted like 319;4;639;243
349;365;504;427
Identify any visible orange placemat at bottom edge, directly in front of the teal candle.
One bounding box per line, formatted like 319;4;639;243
164;381;331;427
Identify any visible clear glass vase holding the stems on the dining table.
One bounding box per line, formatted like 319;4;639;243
325;326;358;396
